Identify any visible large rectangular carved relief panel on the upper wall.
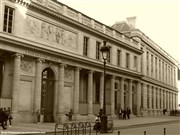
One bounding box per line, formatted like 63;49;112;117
24;16;77;49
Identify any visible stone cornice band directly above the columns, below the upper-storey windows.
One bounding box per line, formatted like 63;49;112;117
0;33;141;78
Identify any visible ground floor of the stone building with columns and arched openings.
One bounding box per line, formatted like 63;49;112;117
0;51;177;122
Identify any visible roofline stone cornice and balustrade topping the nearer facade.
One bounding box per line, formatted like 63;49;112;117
14;0;143;54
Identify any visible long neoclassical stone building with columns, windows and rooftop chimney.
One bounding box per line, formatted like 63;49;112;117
0;0;178;122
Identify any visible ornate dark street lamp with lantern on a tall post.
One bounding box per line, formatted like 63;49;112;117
100;41;109;133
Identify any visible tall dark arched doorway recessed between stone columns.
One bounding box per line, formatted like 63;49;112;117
41;68;54;122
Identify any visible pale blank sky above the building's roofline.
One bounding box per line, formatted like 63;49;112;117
58;0;180;103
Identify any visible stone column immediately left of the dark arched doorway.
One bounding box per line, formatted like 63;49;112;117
34;59;44;112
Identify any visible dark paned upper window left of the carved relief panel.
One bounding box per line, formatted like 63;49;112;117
3;6;14;33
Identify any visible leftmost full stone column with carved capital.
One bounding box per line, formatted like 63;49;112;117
12;53;23;114
